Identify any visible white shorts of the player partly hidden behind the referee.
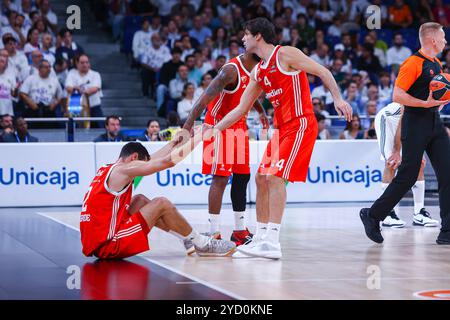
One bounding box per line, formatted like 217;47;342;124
375;102;403;161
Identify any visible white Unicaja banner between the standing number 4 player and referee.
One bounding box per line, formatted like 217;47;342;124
250;140;384;202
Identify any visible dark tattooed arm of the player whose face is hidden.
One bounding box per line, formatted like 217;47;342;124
183;65;237;131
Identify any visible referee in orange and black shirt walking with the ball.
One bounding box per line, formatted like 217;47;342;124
359;22;450;244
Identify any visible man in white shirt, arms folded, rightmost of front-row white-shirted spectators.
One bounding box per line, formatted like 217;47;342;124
64;54;103;127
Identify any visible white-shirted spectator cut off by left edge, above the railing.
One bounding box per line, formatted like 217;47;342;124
0;56;17;115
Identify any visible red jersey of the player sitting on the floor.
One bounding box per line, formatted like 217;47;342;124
80;164;133;256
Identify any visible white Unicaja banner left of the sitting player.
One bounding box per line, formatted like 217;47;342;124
0;143;95;207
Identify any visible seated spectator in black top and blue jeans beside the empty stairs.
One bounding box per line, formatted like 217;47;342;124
156;47;183;111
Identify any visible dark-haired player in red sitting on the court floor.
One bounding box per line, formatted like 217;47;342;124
80;136;235;259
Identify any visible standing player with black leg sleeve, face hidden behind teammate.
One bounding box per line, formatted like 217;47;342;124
183;52;269;245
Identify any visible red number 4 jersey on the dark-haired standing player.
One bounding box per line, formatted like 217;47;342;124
254;46;314;128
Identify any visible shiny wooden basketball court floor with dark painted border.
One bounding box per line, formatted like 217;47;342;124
0;199;450;300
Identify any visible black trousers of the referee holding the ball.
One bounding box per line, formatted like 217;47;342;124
370;107;450;232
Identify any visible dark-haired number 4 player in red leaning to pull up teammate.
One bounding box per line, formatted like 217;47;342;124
204;18;352;259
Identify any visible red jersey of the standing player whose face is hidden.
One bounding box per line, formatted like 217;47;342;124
205;56;250;125
